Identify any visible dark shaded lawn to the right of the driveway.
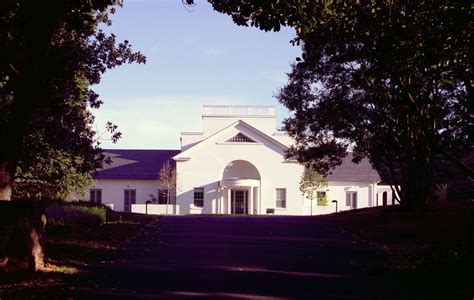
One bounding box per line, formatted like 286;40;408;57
318;203;474;299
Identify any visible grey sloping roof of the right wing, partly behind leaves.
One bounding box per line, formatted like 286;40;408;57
327;152;380;182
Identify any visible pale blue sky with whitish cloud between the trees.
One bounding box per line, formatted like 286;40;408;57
93;0;301;149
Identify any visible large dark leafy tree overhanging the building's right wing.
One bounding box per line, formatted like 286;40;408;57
202;0;474;209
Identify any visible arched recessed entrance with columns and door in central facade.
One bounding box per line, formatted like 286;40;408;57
218;160;260;214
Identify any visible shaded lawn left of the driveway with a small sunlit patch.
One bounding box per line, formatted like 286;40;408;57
0;213;157;299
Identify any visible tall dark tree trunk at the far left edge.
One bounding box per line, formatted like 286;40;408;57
0;0;60;200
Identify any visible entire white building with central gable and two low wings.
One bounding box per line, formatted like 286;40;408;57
82;105;392;215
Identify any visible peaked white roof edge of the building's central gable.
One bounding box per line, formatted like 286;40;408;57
173;120;288;160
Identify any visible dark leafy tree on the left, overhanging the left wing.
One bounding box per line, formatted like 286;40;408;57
0;0;145;200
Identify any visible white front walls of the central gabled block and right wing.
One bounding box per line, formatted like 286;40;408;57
177;115;390;215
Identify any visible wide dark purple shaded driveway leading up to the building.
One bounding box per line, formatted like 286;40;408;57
63;216;402;299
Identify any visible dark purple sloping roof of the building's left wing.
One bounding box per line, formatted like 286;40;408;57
91;149;181;180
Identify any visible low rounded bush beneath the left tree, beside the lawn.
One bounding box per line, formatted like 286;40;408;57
46;202;107;225
